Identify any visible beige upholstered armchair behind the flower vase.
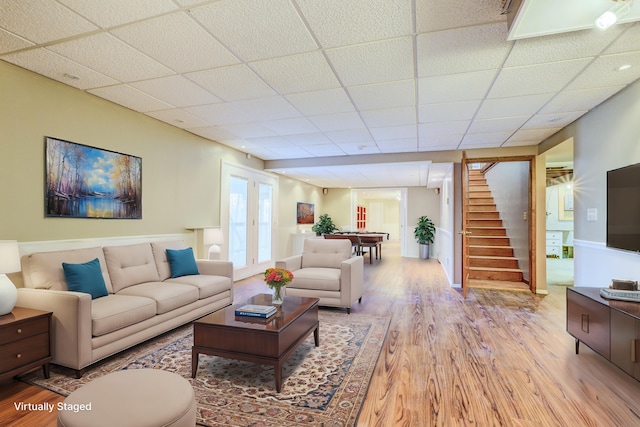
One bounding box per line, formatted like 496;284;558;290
276;239;364;313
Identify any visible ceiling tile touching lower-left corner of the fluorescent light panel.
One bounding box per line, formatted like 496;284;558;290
417;23;512;77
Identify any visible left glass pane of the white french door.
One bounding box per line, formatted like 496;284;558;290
229;176;249;268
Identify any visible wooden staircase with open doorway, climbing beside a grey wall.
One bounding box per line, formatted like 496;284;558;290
466;170;523;282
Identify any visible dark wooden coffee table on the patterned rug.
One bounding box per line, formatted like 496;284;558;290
191;294;320;392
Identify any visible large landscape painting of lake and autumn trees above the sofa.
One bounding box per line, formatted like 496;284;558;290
44;136;142;219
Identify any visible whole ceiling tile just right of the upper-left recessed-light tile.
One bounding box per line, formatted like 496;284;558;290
48;33;175;83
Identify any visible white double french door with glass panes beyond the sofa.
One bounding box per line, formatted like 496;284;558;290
220;161;278;279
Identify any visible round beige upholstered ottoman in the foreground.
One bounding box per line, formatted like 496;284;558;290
58;369;196;427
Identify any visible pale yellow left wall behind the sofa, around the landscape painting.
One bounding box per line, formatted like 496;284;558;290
0;61;263;242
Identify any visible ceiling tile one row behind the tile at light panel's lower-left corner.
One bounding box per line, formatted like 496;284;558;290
418;69;498;105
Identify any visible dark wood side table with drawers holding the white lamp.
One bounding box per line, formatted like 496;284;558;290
0;307;53;381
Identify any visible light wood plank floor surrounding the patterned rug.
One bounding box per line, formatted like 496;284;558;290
0;242;640;427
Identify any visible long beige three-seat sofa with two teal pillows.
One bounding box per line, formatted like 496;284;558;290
17;241;233;377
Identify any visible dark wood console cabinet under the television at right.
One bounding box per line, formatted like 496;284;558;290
567;288;640;380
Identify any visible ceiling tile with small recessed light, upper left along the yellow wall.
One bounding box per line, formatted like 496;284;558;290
0;48;120;90
